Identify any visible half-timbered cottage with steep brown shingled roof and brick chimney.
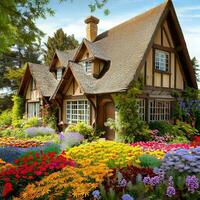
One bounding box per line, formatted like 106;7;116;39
19;0;197;139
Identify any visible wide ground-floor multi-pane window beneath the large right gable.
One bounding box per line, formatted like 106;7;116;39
149;100;171;121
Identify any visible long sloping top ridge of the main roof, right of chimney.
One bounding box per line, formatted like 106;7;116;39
94;0;169;42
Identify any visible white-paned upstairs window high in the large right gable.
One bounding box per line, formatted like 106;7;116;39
155;49;169;71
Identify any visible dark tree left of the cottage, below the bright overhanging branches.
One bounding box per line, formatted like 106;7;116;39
0;44;41;112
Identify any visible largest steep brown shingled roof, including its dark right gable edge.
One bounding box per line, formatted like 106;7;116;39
69;0;197;94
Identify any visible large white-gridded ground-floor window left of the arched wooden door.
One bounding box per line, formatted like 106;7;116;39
66;100;90;124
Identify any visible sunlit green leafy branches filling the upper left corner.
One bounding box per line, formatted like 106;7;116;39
0;0;54;53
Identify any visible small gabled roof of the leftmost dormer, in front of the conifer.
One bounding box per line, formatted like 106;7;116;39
50;48;77;71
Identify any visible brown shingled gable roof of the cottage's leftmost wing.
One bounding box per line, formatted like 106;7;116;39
18;63;58;97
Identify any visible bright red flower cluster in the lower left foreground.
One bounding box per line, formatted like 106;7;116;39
0;151;75;197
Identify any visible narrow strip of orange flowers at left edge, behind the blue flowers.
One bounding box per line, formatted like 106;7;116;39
0;137;44;148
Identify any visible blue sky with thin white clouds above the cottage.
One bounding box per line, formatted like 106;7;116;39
37;0;200;85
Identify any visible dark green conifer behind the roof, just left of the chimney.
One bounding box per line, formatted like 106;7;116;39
44;29;78;65
